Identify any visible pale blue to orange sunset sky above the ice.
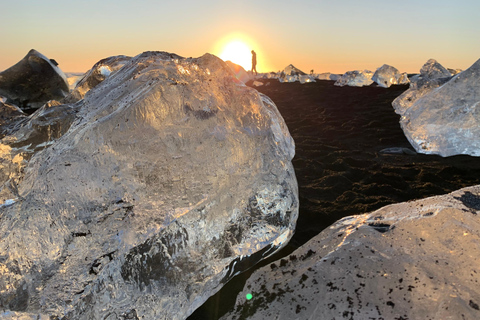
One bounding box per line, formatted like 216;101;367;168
0;0;480;73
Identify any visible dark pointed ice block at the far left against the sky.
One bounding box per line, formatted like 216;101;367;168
0;49;69;110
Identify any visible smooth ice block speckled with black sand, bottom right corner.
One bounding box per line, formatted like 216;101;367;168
222;186;480;320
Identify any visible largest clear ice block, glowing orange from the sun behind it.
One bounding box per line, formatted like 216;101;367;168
0;52;298;319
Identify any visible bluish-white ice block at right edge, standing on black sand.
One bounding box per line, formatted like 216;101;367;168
400;60;480;157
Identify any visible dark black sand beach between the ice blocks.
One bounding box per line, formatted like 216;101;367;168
188;80;480;320
